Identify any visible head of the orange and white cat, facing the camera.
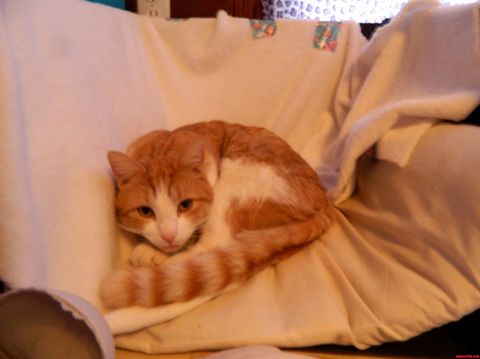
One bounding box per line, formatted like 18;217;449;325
108;131;218;253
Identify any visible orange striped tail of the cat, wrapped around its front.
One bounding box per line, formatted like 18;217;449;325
101;207;334;309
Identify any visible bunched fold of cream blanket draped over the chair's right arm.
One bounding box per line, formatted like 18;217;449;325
330;0;480;203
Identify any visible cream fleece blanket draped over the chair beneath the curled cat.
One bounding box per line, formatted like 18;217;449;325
0;0;480;352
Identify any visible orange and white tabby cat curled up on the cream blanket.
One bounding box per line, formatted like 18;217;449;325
101;120;335;310
